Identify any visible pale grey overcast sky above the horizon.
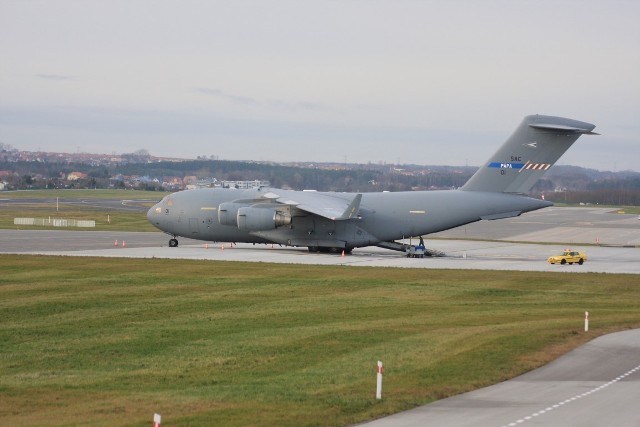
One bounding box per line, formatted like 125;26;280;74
0;0;640;171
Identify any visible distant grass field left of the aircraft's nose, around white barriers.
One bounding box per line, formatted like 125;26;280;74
0;190;168;231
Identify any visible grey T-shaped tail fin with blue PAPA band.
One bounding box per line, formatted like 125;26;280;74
460;115;598;193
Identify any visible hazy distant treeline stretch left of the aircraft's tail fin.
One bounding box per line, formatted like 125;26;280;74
0;160;474;192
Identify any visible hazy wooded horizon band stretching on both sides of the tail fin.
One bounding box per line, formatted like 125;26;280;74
0;160;640;205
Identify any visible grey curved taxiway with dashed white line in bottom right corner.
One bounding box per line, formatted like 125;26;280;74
361;330;640;427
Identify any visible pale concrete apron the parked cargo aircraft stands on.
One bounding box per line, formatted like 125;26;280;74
0;208;640;274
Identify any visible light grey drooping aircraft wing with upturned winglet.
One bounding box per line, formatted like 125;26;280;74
264;190;362;221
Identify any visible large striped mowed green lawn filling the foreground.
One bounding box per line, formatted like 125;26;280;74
0;255;640;426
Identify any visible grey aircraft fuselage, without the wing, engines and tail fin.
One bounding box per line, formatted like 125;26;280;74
148;188;551;248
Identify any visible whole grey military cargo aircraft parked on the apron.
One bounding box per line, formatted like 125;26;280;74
147;115;597;253
